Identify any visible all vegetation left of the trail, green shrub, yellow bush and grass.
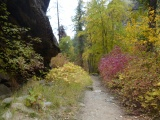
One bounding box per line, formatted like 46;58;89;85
0;3;92;120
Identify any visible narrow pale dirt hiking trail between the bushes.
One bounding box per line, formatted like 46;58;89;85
78;76;148;120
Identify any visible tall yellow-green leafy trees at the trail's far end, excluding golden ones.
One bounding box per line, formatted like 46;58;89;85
83;0;128;72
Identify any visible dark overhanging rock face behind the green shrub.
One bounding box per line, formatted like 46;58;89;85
5;0;60;66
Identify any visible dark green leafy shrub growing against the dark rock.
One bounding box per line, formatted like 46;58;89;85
0;3;43;84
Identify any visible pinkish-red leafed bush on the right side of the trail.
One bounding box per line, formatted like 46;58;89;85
98;46;131;80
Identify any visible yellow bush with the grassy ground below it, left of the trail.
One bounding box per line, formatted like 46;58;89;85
4;63;92;119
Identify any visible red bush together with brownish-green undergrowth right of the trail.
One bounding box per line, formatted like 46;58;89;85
99;48;160;119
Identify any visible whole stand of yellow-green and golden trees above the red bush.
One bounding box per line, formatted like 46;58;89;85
69;0;160;72
